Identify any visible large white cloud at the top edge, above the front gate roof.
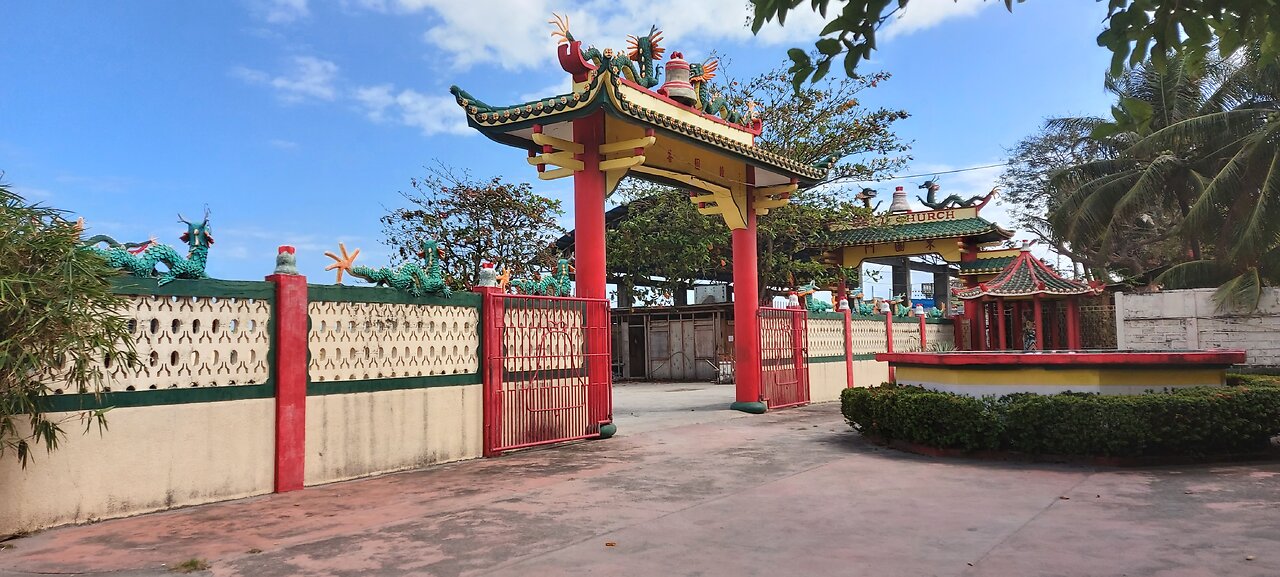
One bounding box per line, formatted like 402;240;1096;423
346;0;823;70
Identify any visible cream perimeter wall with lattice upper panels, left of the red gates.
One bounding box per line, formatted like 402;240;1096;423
0;278;484;536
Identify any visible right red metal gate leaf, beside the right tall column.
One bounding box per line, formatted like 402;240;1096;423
760;307;809;409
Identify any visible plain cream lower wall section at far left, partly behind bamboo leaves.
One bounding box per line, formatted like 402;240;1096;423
0;399;275;535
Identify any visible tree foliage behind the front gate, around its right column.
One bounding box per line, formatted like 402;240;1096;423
607;61;909;298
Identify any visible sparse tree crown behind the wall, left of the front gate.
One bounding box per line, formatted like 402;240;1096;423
381;165;564;290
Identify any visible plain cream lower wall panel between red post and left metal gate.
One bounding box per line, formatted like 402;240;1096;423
305;385;484;485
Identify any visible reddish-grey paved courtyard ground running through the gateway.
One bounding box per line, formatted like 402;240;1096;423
0;384;1280;577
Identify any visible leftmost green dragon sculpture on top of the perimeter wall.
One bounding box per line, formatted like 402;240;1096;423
83;209;214;284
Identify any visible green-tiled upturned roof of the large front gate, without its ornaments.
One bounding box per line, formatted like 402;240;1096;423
449;68;828;184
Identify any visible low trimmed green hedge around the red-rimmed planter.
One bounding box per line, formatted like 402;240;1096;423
841;384;1280;457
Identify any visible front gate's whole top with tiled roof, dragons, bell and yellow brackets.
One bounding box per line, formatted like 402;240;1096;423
449;17;829;229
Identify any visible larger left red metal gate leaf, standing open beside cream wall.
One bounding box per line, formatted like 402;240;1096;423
484;293;613;457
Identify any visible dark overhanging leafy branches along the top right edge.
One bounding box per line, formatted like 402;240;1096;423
751;0;1280;90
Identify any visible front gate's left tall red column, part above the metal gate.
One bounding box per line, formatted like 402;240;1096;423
573;111;608;298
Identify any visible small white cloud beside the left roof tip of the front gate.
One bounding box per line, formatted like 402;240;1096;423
352;84;472;136
